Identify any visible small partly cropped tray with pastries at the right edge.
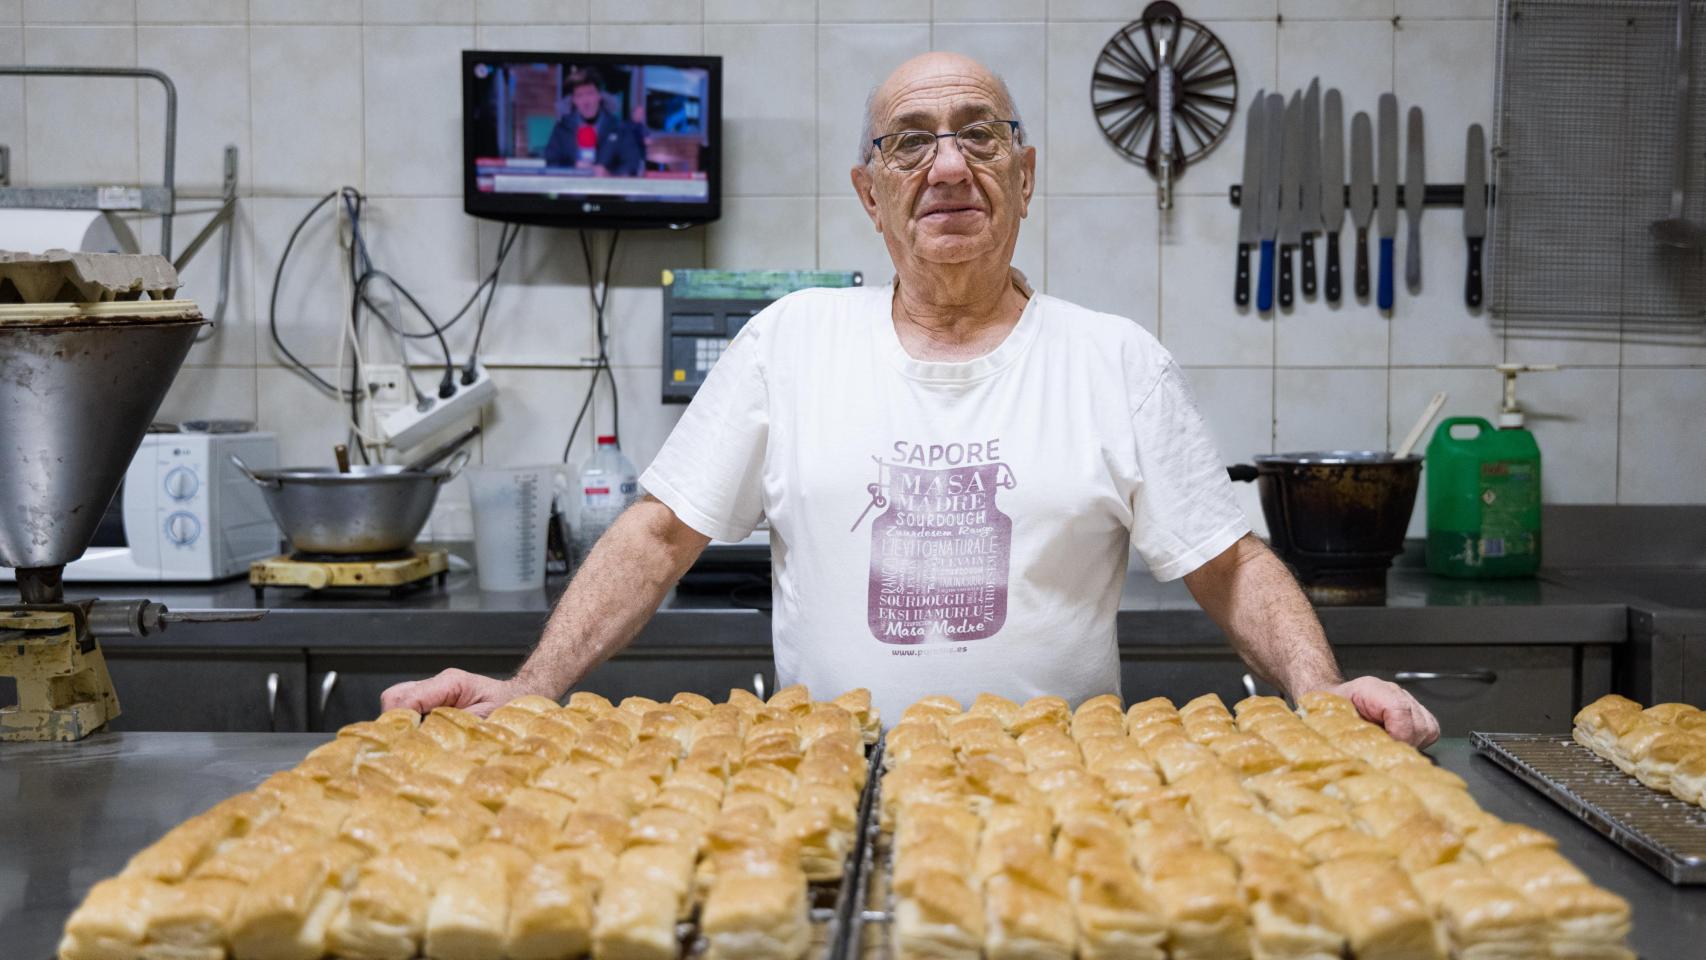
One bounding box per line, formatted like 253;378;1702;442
1474;694;1706;883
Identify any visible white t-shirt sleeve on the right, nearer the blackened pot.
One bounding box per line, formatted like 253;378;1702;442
1131;358;1250;581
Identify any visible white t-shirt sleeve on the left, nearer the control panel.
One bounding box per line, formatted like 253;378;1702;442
640;314;769;541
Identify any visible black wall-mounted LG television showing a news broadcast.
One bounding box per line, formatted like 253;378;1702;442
462;49;722;227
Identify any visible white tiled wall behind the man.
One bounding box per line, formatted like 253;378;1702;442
0;0;1706;535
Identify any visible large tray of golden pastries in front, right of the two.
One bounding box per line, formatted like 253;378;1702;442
846;694;1633;960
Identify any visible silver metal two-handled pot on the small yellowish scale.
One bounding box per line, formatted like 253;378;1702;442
230;450;469;556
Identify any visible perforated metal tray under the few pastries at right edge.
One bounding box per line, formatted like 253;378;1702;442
1469;733;1706;885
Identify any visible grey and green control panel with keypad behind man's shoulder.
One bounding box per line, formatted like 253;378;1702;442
664;269;865;404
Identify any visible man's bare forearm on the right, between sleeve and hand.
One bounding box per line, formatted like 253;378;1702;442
1186;535;1343;697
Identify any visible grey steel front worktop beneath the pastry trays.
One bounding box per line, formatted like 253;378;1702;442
0;733;1706;960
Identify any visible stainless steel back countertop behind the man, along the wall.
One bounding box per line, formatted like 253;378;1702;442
67;555;1628;653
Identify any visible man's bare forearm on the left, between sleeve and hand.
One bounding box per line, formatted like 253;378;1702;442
515;496;710;699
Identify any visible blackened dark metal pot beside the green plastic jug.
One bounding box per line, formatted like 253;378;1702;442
1230;450;1421;604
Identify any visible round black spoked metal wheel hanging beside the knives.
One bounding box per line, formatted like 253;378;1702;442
1090;0;1239;174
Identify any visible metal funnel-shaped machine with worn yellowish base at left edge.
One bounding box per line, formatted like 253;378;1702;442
0;251;259;740
